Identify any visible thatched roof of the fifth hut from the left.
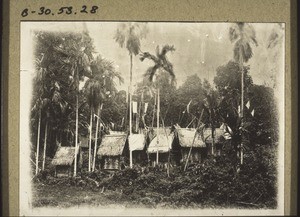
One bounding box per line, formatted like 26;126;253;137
176;128;206;148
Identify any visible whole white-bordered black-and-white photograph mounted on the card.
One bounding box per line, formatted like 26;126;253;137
19;21;285;216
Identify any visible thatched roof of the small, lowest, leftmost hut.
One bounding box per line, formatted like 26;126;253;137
52;146;78;166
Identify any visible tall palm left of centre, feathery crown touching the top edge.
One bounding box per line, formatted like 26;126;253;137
114;23;148;134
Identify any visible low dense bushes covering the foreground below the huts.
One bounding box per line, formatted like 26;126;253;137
34;142;277;208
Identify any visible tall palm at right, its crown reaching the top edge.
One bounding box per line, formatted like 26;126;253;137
229;23;257;164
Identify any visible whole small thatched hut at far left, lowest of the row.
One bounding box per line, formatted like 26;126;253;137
52;146;81;177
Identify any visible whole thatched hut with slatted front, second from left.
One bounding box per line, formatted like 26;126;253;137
97;133;129;170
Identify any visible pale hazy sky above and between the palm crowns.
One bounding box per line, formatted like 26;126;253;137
21;22;284;90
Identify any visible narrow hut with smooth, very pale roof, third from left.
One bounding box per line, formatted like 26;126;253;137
128;133;147;165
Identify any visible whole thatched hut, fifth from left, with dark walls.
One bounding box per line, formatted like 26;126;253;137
175;128;206;163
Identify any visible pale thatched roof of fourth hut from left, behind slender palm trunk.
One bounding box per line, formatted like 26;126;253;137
148;128;174;153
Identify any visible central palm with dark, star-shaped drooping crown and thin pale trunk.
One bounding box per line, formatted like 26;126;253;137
140;45;175;164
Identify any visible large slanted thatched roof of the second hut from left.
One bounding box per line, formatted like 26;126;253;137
97;133;127;156
